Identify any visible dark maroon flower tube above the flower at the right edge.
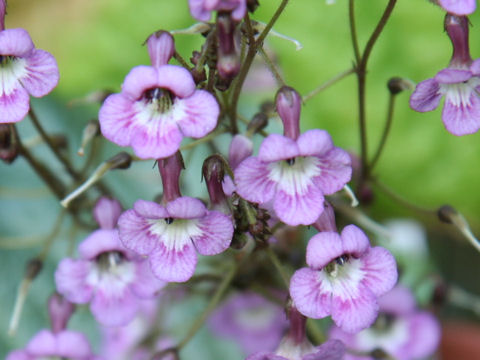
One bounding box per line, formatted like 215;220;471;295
445;14;472;67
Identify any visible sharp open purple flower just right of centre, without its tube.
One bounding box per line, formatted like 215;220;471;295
235;129;352;226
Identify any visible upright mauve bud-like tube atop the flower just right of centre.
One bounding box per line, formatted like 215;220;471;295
275;86;302;140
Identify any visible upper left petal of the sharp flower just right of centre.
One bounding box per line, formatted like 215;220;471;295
258;134;300;162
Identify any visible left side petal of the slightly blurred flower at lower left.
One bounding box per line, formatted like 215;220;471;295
55;258;92;304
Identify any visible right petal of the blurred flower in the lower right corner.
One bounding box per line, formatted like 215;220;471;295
399;311;442;359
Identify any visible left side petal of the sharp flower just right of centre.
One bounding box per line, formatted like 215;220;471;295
235;156;276;204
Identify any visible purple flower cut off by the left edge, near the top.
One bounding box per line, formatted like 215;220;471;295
0;28;59;123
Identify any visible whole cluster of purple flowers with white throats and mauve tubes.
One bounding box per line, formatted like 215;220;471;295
0;0;448;360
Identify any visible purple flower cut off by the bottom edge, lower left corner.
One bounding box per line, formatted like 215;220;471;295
6;330;94;360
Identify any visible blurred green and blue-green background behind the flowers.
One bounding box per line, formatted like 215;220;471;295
0;0;480;359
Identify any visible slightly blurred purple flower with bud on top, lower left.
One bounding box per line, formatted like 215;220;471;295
55;198;164;326
